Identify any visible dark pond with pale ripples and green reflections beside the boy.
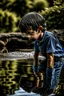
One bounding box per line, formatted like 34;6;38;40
0;51;44;96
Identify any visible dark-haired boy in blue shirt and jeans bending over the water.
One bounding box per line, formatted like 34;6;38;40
19;12;64;96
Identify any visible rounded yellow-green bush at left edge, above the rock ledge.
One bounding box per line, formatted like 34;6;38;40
0;10;18;32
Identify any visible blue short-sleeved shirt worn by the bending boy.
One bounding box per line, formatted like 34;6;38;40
34;31;64;57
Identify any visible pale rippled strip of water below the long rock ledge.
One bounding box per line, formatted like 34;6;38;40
0;52;45;60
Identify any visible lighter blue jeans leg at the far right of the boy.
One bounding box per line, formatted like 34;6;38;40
50;61;64;89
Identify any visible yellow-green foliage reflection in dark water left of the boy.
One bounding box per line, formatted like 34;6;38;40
0;60;32;96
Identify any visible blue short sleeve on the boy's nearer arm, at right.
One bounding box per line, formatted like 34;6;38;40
46;37;56;53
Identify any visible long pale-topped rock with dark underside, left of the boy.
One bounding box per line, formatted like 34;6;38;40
0;32;34;49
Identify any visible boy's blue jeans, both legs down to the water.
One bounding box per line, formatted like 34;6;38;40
39;61;64;90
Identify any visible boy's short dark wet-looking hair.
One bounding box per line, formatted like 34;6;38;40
19;12;46;32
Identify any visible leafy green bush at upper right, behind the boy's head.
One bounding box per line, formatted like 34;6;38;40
41;5;64;29
